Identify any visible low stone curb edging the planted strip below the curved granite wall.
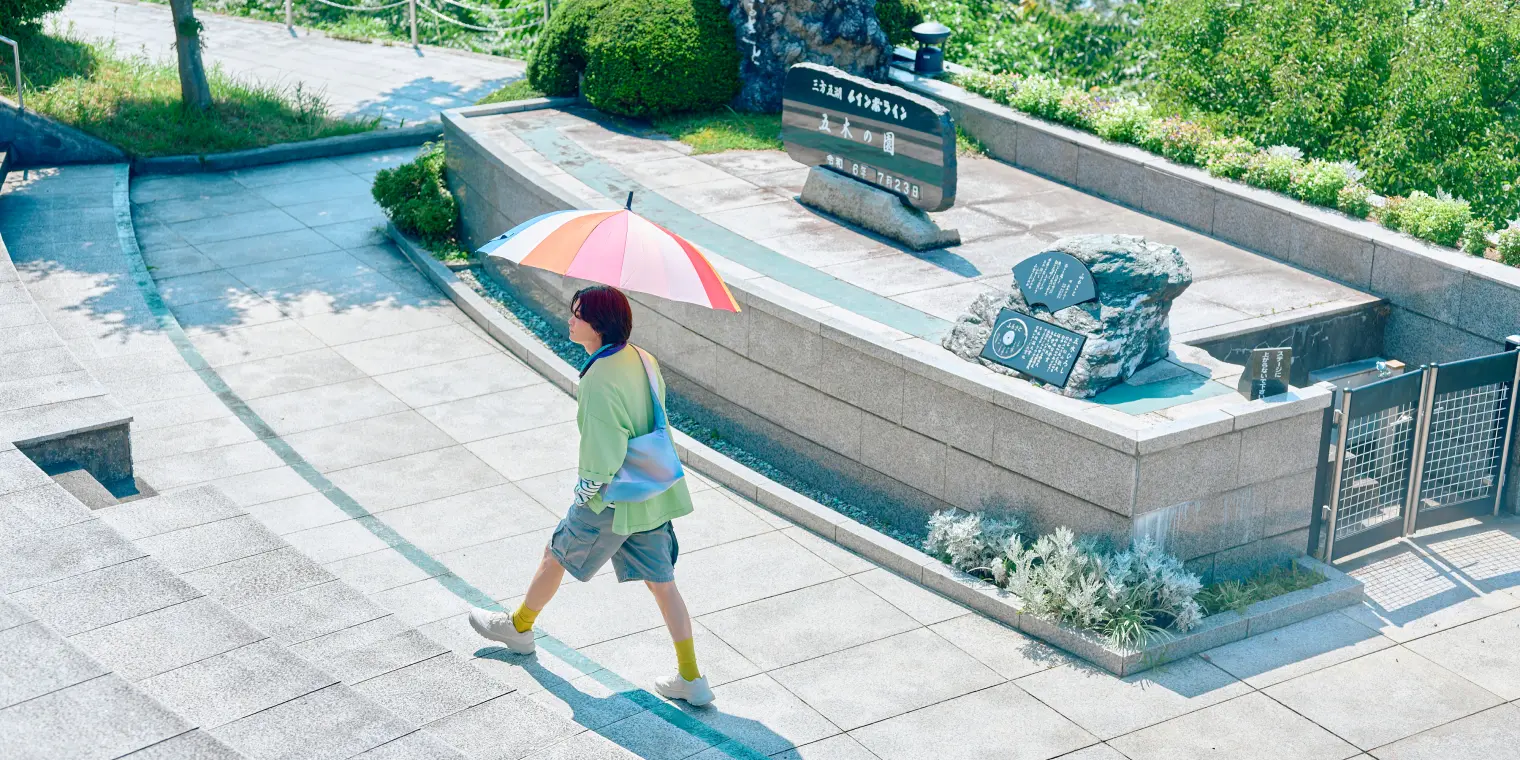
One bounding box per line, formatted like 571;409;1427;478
388;225;1365;676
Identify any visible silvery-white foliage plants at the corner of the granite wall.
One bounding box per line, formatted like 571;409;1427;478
924;511;1204;649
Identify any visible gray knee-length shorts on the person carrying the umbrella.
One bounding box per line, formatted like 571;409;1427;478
549;506;681;584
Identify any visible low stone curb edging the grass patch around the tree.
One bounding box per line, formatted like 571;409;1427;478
132;123;444;175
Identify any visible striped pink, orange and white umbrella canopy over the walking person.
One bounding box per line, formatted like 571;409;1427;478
480;210;739;312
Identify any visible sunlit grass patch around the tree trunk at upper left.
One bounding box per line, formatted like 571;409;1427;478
0;24;378;157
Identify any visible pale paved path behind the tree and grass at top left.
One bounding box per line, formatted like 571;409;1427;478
53;0;526;126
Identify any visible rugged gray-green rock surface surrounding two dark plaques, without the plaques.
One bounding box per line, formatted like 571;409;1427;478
942;236;1193;398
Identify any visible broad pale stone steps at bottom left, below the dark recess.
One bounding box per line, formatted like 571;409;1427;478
0;474;538;760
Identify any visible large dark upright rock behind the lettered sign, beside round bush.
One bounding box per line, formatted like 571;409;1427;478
720;0;892;111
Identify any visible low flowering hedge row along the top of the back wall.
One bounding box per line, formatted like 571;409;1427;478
953;71;1494;255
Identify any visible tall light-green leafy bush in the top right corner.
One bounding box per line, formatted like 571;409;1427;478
1142;0;1520;239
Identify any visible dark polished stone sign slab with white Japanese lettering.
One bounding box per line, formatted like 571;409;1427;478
781;64;956;211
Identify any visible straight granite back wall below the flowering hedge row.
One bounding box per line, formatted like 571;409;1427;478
889;56;1520;357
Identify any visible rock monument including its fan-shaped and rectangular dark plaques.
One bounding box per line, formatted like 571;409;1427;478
942;236;1193;398
